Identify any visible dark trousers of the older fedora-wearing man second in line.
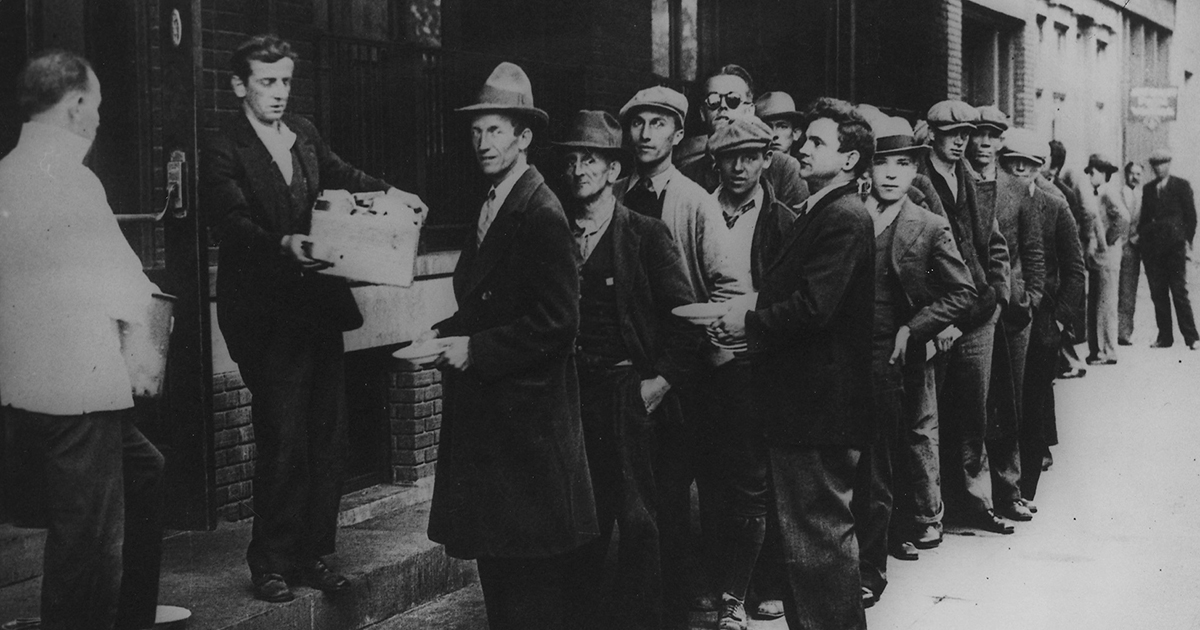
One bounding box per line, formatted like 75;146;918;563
571;367;662;629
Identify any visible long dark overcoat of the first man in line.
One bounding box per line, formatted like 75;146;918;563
428;167;598;558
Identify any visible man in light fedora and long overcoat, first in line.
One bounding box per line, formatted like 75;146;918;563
428;62;596;630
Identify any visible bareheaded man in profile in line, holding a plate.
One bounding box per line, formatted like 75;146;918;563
715;98;875;630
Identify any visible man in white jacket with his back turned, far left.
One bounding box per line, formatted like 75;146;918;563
0;50;163;630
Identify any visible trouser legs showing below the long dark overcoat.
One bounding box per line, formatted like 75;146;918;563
475;556;575;630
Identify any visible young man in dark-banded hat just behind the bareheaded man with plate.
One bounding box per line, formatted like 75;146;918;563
851;116;974;606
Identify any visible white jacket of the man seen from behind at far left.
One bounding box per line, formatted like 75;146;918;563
0;122;157;415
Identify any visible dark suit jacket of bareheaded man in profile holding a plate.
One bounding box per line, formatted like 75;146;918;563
745;184;875;446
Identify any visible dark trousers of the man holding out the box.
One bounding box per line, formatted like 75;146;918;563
238;328;347;576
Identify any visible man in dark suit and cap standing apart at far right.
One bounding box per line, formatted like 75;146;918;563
1138;149;1200;350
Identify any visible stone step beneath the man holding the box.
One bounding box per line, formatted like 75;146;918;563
0;503;476;630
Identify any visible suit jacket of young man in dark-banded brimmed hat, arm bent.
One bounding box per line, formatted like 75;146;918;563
889;198;976;343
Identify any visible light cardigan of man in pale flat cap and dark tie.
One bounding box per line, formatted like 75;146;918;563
613;166;748;302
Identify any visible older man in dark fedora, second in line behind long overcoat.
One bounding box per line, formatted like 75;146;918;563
554;110;702;629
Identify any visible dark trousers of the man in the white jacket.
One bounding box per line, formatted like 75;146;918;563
4;407;163;630
